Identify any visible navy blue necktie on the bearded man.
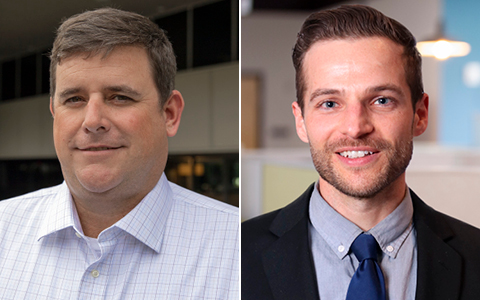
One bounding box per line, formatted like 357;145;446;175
346;233;386;300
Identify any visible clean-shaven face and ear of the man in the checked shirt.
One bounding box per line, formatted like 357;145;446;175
51;46;183;202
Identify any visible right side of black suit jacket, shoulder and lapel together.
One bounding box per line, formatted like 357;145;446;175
412;193;480;299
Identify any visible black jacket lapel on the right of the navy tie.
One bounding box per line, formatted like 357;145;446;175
411;192;462;300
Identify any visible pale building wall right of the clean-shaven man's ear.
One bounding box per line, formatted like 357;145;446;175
169;62;239;153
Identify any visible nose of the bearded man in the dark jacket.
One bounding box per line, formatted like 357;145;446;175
342;103;374;139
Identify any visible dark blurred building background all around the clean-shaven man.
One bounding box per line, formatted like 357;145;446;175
0;0;239;206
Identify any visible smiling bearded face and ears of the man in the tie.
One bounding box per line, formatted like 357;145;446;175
293;37;428;198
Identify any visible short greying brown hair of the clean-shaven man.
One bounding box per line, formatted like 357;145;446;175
50;8;177;105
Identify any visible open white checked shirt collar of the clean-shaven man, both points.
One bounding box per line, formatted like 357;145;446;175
37;174;174;253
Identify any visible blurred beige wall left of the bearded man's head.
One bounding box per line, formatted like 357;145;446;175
241;13;308;148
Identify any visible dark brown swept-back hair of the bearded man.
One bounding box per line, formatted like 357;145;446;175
292;5;423;110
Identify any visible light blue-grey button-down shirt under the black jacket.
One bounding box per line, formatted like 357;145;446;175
309;184;417;300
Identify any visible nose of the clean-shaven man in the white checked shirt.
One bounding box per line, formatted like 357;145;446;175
82;97;110;133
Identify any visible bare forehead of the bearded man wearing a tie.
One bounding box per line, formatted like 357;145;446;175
303;37;406;90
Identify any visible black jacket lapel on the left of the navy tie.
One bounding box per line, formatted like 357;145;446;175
262;185;319;299
